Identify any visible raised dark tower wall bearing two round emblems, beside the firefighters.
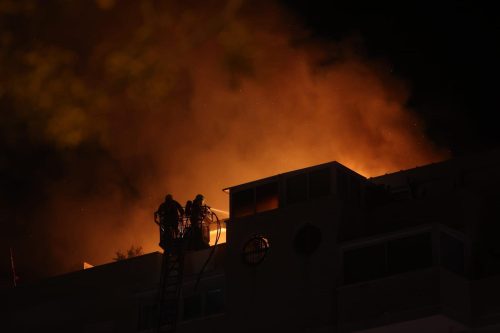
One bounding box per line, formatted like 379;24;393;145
226;163;363;332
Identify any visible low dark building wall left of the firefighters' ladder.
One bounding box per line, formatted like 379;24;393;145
8;253;161;332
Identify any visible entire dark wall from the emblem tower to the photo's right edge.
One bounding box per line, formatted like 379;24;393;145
226;153;500;332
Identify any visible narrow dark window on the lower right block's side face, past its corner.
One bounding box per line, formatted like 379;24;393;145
439;232;465;274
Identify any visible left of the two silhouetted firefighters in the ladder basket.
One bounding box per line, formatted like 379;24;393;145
154;194;184;249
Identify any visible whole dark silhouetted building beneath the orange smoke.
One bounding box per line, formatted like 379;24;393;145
2;151;500;333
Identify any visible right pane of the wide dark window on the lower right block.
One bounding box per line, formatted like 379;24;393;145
387;233;432;274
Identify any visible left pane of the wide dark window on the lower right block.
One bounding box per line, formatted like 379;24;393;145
344;244;386;284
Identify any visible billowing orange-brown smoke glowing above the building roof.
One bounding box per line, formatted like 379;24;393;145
0;0;444;278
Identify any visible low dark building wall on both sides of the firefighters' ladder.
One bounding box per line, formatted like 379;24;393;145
1;245;225;332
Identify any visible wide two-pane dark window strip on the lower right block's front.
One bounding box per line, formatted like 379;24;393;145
343;232;432;284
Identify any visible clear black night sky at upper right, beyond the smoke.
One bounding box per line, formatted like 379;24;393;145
286;0;500;155
